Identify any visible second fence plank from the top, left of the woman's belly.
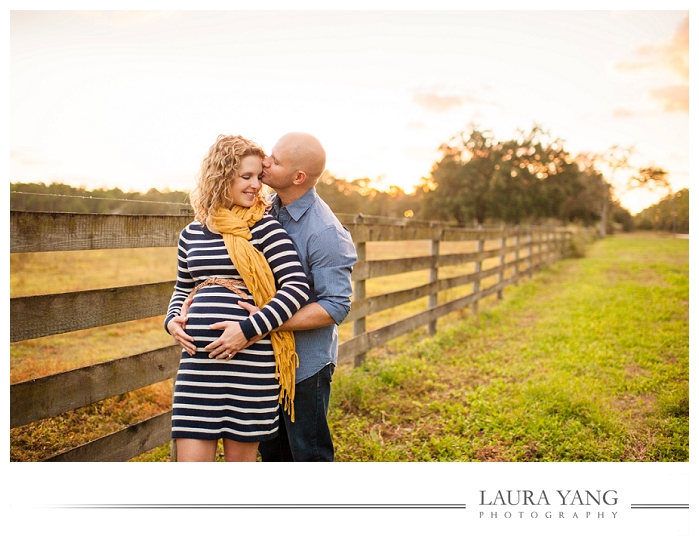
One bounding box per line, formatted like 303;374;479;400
10;280;175;342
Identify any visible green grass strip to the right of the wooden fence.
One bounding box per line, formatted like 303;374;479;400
330;234;689;461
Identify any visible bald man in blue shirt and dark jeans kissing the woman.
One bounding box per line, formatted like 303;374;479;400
208;133;357;461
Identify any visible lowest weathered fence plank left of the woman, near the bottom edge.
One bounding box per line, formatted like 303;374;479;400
42;410;172;462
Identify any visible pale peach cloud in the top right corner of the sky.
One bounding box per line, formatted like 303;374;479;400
616;14;689;82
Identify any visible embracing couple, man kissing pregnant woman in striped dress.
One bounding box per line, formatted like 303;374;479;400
165;133;357;461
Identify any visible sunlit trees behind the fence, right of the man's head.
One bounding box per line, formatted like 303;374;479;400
318;125;686;235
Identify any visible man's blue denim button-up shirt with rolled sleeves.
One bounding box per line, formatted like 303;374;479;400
271;188;357;383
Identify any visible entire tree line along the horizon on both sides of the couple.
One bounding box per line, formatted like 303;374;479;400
10;125;689;235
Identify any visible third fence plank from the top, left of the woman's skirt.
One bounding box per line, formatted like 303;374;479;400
10;345;181;428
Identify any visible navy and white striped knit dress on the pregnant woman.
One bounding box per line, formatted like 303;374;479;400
165;215;309;442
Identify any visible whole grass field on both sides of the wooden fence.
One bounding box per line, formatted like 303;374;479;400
10;234;688;461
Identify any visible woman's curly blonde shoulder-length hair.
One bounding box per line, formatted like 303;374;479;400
189;135;266;224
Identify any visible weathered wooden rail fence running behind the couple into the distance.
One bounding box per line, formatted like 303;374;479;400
10;211;570;461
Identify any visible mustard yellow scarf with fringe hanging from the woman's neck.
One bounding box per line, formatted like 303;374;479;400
209;198;299;422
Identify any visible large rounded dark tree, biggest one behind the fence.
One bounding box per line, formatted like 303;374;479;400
421;125;581;225
